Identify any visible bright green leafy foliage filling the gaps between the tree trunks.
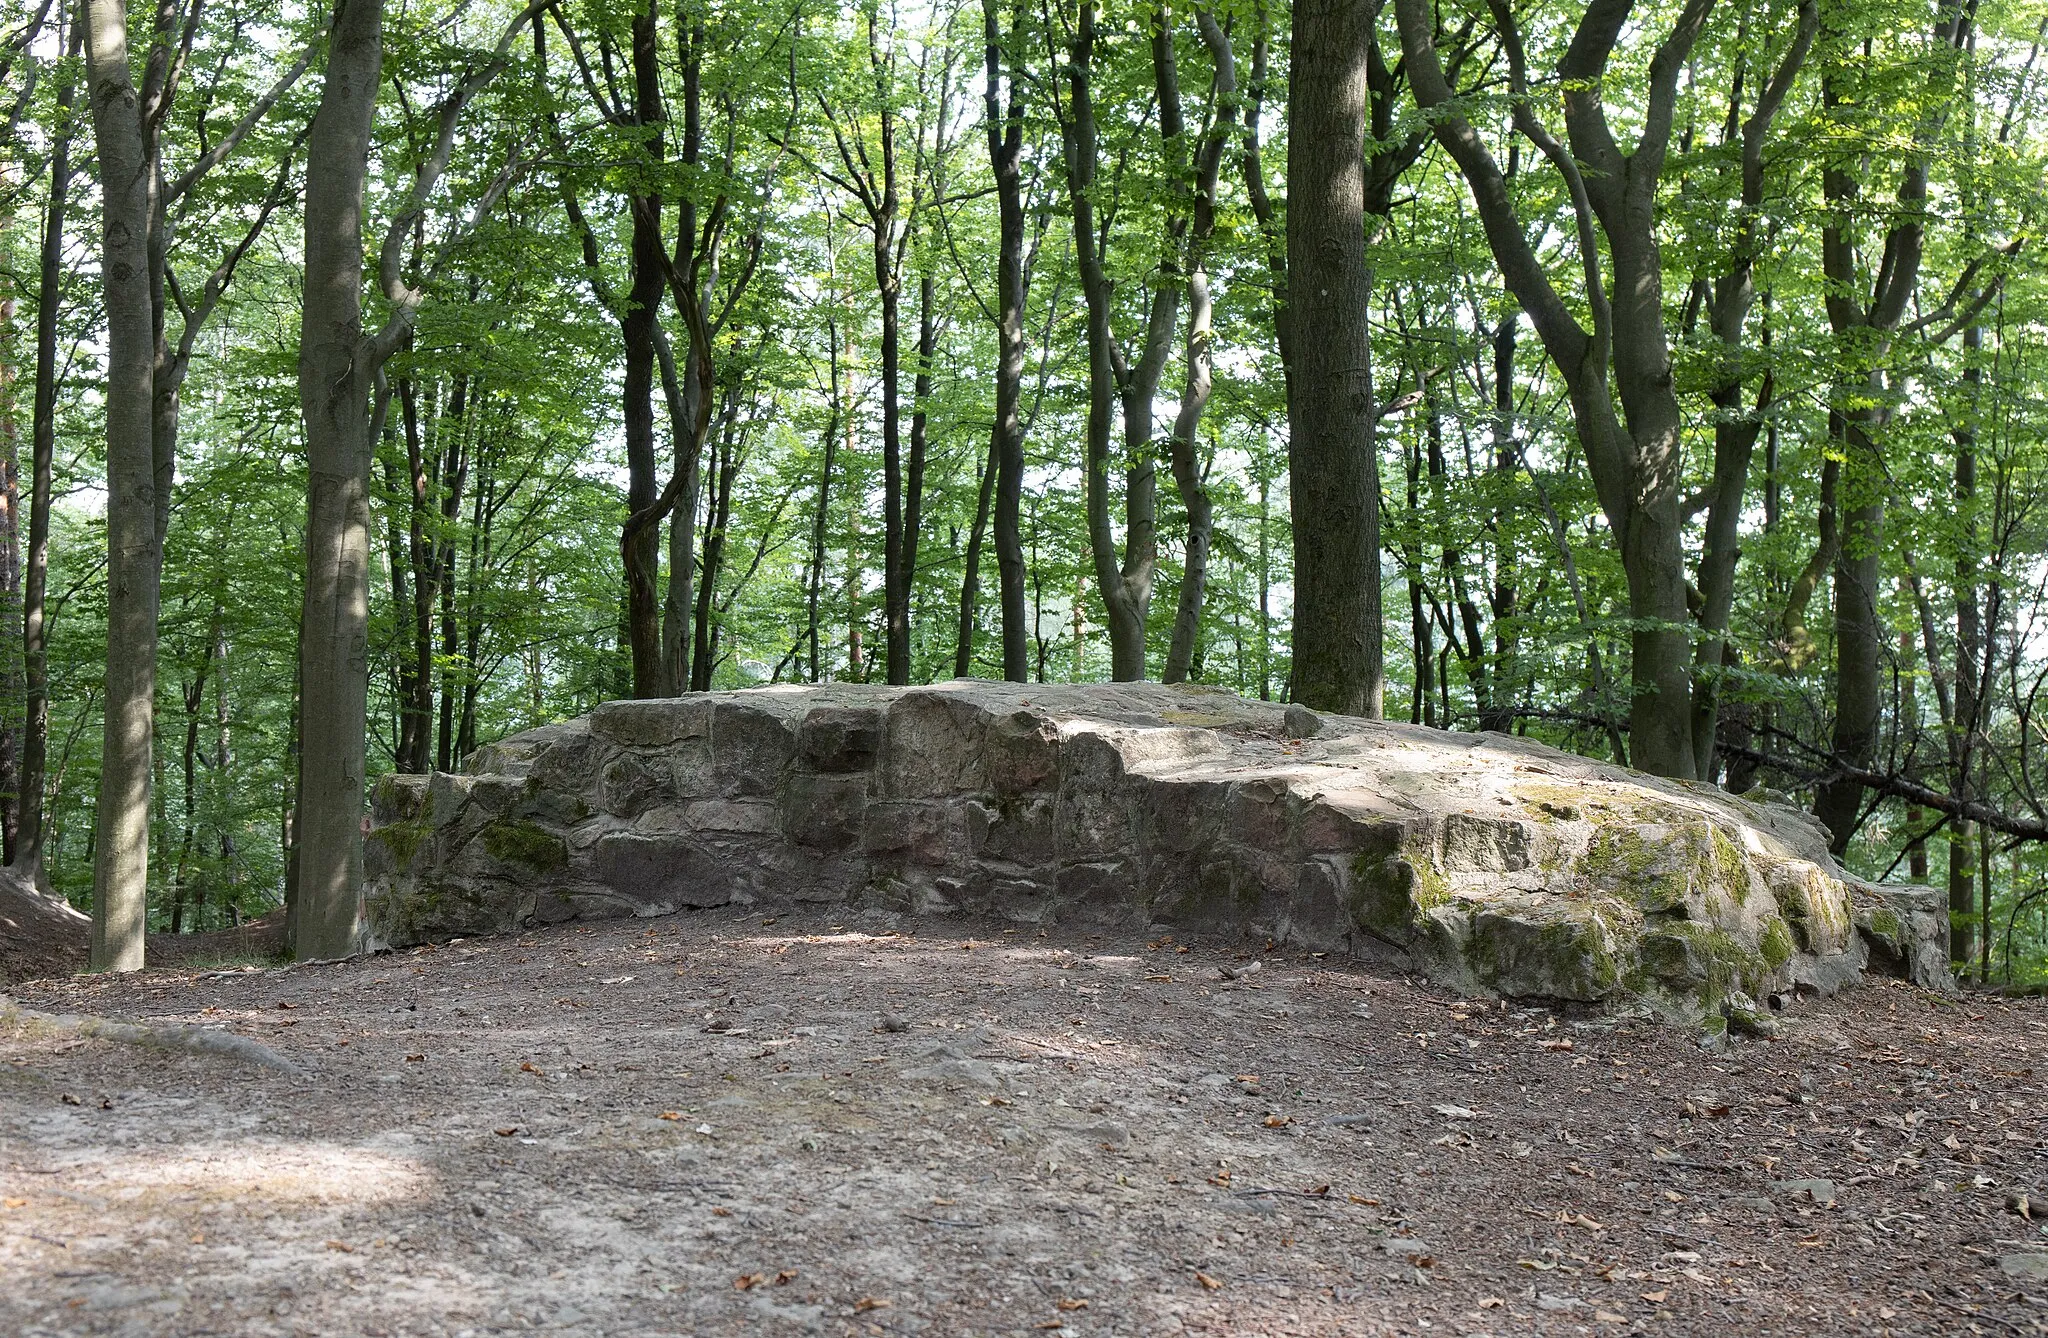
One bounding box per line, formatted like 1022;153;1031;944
12;0;2048;981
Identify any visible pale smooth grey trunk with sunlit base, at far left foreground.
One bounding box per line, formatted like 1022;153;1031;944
86;0;158;971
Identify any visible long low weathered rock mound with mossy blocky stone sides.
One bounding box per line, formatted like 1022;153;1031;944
369;680;1952;1029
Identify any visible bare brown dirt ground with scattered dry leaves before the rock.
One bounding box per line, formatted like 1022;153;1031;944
0;912;2048;1336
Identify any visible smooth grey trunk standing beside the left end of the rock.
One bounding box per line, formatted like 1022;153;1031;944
287;0;383;961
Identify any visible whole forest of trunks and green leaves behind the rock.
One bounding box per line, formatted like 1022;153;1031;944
0;0;2048;984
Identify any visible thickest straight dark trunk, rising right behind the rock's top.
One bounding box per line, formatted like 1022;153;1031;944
1284;0;1384;719
